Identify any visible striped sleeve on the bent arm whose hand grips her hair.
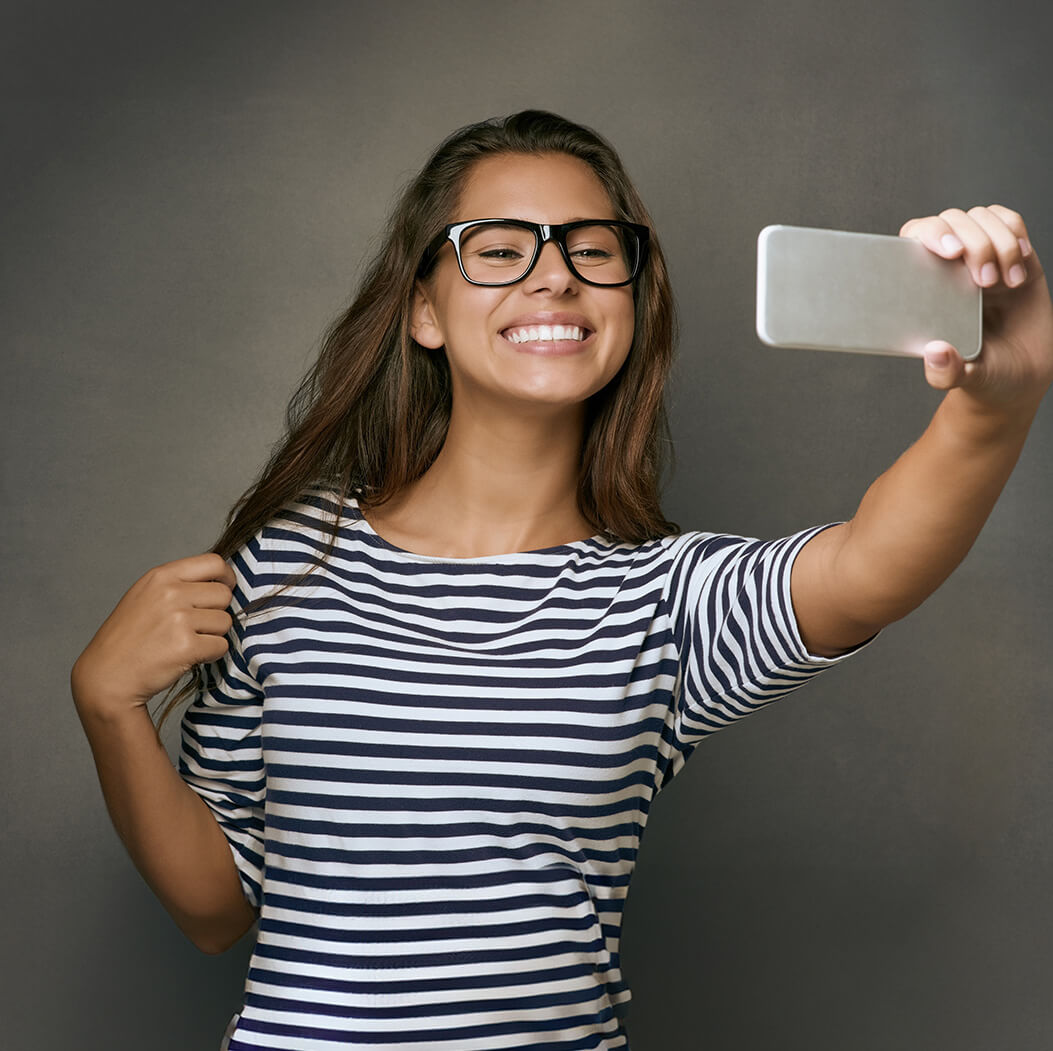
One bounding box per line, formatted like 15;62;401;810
179;538;266;909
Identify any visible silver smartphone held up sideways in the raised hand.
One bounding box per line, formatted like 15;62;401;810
757;226;982;361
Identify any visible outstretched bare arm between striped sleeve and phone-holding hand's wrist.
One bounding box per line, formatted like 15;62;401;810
794;390;1037;653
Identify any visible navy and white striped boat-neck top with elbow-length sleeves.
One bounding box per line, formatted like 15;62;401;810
180;492;855;1051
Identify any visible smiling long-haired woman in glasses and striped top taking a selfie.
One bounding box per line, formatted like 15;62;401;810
73;112;1053;1051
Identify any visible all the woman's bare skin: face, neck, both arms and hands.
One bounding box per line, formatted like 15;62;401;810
72;155;1053;952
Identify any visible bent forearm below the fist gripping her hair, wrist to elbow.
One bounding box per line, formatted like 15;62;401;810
75;691;255;952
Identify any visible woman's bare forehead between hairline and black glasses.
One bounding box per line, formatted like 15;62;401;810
454;154;616;222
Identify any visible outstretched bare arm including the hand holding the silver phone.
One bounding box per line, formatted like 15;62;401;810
791;205;1053;656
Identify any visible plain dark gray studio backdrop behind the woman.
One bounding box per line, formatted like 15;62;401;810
0;0;1053;1051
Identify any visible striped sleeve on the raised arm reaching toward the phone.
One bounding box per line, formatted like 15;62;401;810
670;526;867;757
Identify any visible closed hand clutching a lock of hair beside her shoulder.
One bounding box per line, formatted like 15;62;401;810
71;552;236;716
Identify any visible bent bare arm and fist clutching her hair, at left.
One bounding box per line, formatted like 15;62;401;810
71;555;255;952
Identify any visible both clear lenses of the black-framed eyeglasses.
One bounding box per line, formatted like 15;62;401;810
460;222;639;284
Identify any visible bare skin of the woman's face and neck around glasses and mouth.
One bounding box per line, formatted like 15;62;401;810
367;154;633;558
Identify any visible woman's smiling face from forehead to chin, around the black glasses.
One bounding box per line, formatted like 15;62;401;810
412;154;633;412
